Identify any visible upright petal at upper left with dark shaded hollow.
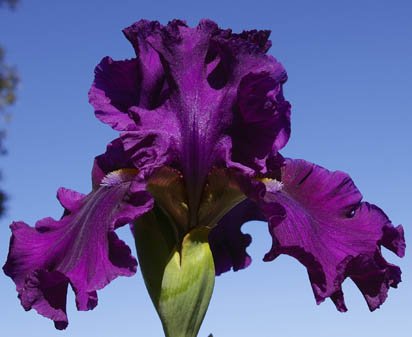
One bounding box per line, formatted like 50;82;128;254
89;20;168;131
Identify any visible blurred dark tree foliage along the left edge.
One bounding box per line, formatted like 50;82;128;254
0;0;19;216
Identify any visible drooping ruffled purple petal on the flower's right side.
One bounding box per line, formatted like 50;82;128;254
261;160;405;311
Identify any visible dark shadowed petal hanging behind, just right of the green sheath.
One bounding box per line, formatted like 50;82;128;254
209;200;264;275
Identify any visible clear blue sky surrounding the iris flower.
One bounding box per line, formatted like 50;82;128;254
0;0;412;337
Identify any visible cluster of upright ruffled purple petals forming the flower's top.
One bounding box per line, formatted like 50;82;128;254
90;20;290;217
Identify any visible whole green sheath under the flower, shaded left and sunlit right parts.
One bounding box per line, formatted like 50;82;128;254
135;209;215;337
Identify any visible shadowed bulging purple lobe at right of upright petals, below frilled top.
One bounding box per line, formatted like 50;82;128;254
233;72;291;165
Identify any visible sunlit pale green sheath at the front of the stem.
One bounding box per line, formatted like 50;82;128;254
159;228;215;337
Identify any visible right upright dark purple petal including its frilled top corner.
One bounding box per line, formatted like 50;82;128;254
211;30;291;171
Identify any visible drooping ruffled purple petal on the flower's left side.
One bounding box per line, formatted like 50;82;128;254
3;181;152;329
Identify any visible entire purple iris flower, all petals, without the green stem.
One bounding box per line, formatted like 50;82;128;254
3;20;405;329
